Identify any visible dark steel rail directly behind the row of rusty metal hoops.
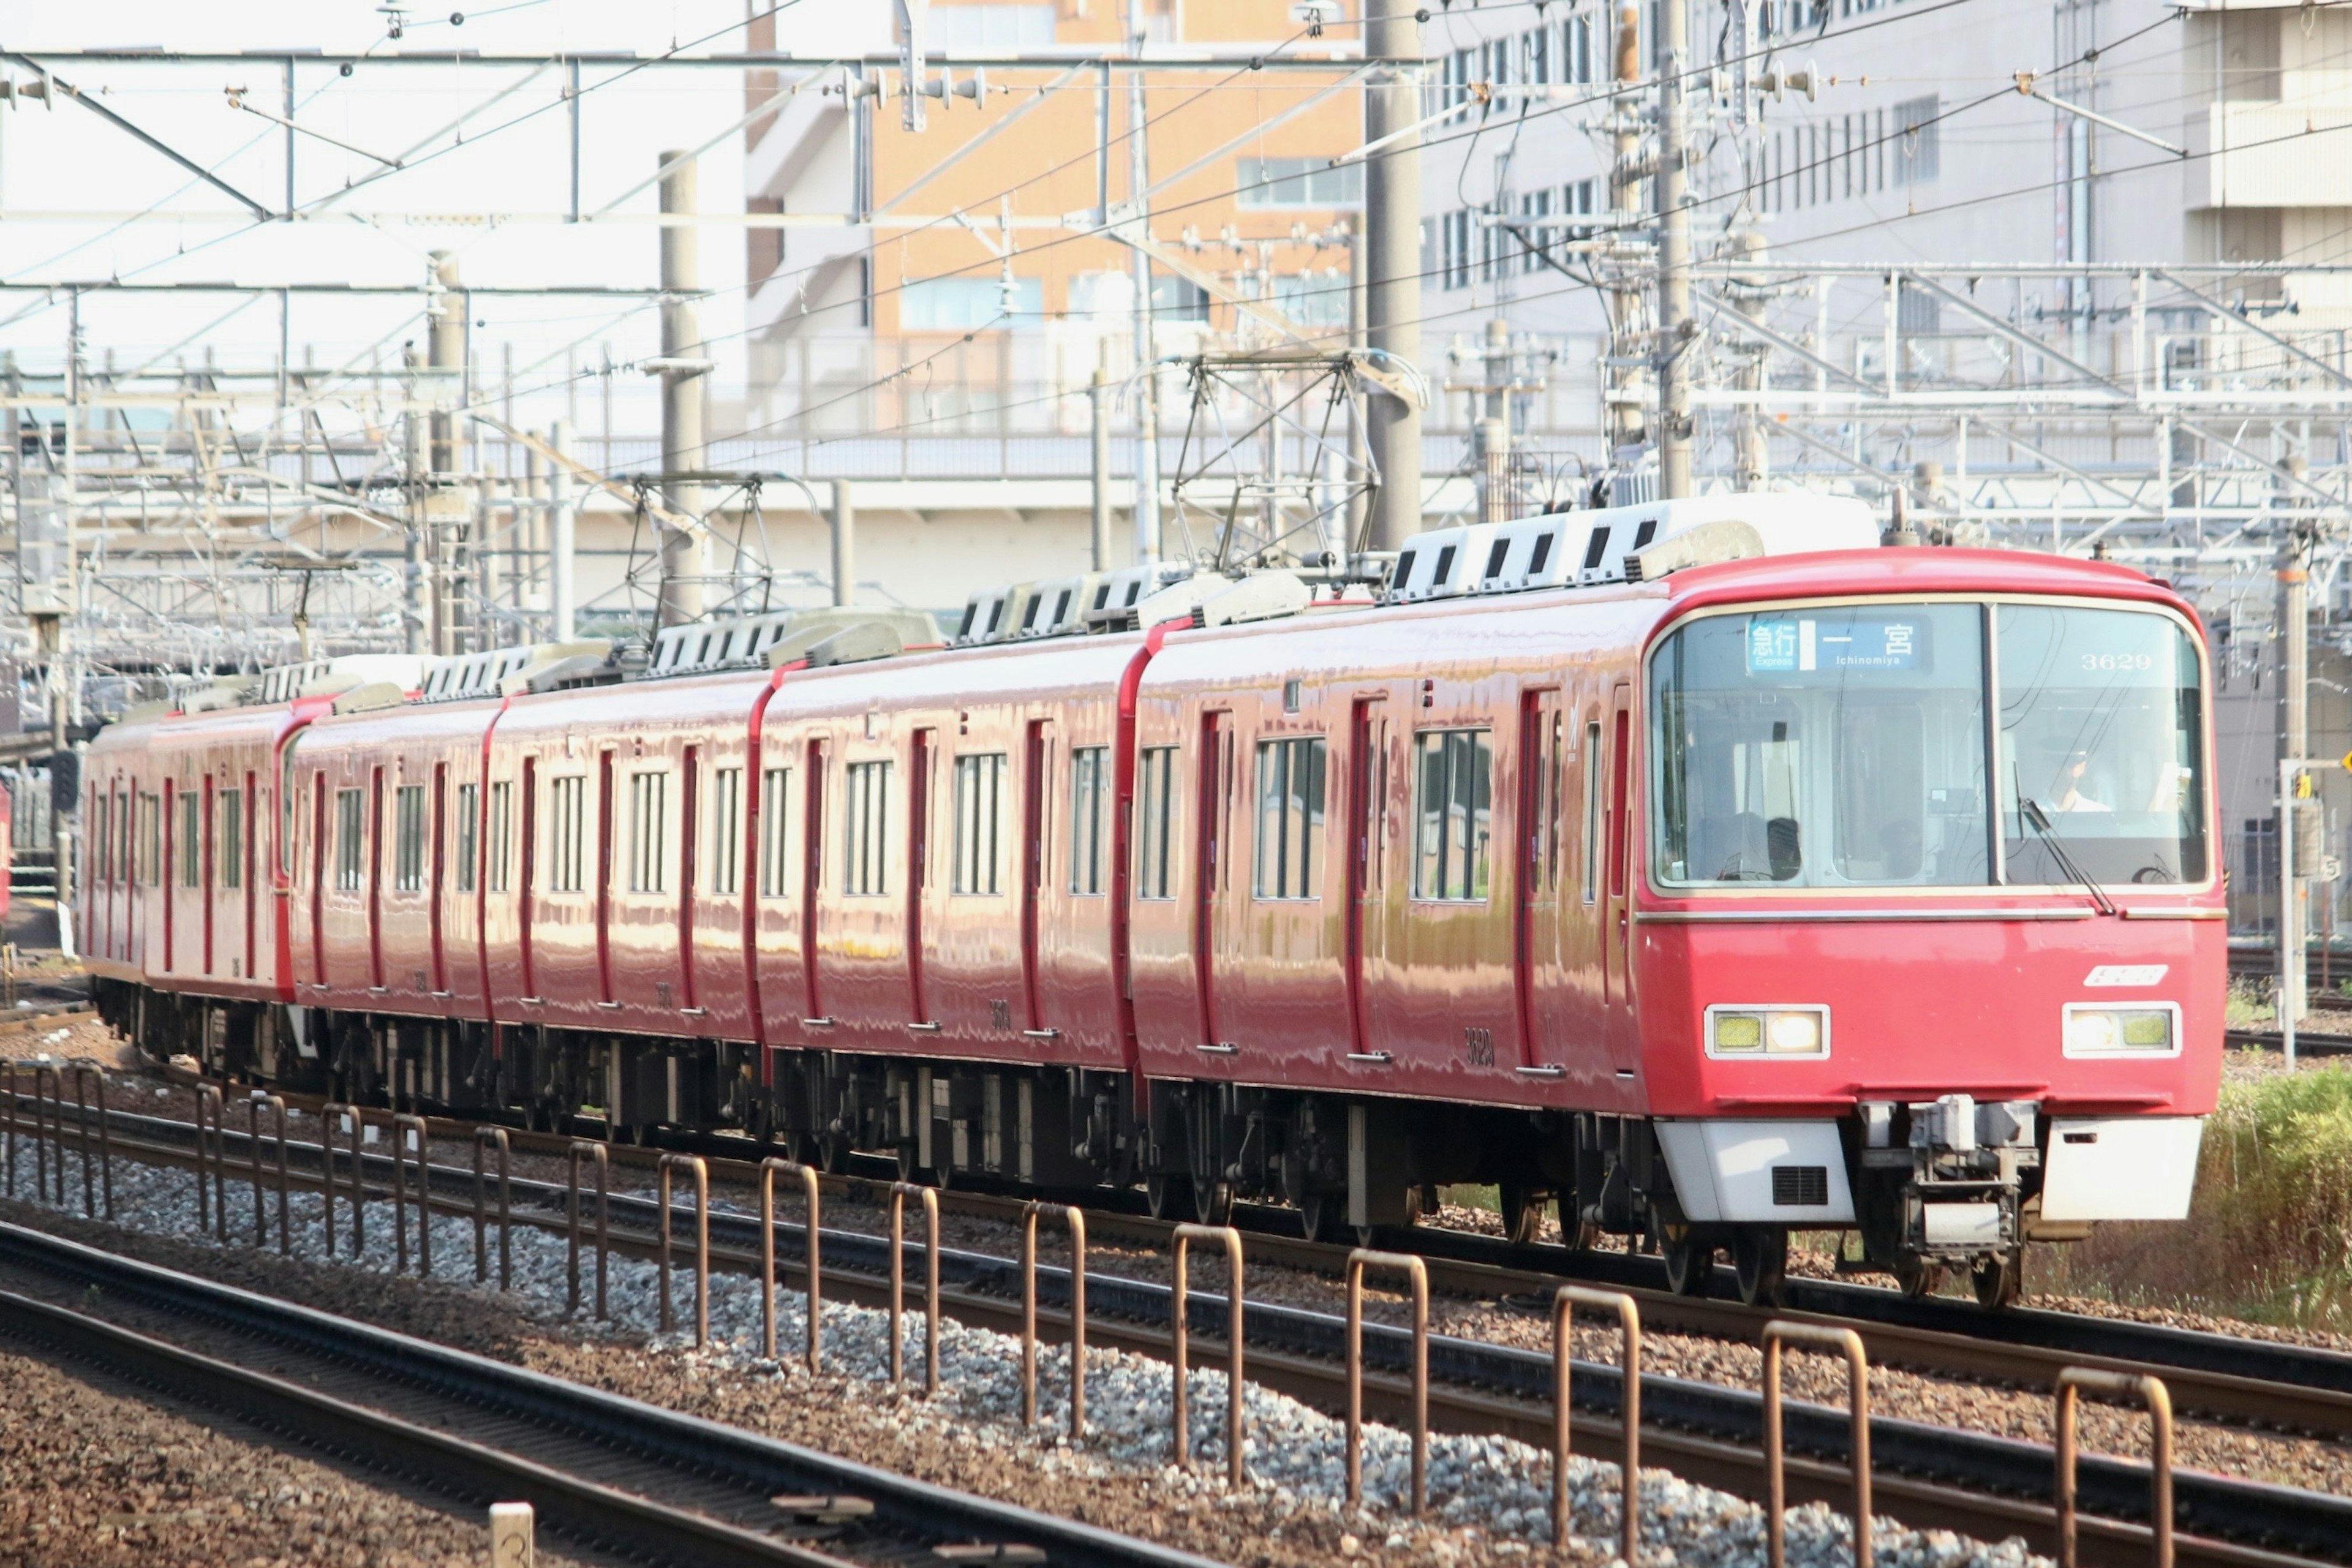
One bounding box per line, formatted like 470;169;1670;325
9;1124;2352;1568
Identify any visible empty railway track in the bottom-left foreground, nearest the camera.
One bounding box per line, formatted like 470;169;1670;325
0;1225;1207;1568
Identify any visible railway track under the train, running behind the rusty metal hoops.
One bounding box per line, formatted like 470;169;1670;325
4;1112;2352;1566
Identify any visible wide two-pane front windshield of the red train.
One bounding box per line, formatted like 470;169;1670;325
1651;602;2206;889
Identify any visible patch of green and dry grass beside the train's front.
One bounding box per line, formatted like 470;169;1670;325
2027;1065;2352;1330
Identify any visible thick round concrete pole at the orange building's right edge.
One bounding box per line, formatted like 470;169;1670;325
1364;0;1420;550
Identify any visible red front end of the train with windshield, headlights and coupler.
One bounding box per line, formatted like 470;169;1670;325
1637;557;2225;1305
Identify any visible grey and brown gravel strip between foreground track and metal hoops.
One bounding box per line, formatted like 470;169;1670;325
7;1156;2046;1568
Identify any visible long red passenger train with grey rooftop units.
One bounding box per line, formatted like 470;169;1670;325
80;496;2225;1305
